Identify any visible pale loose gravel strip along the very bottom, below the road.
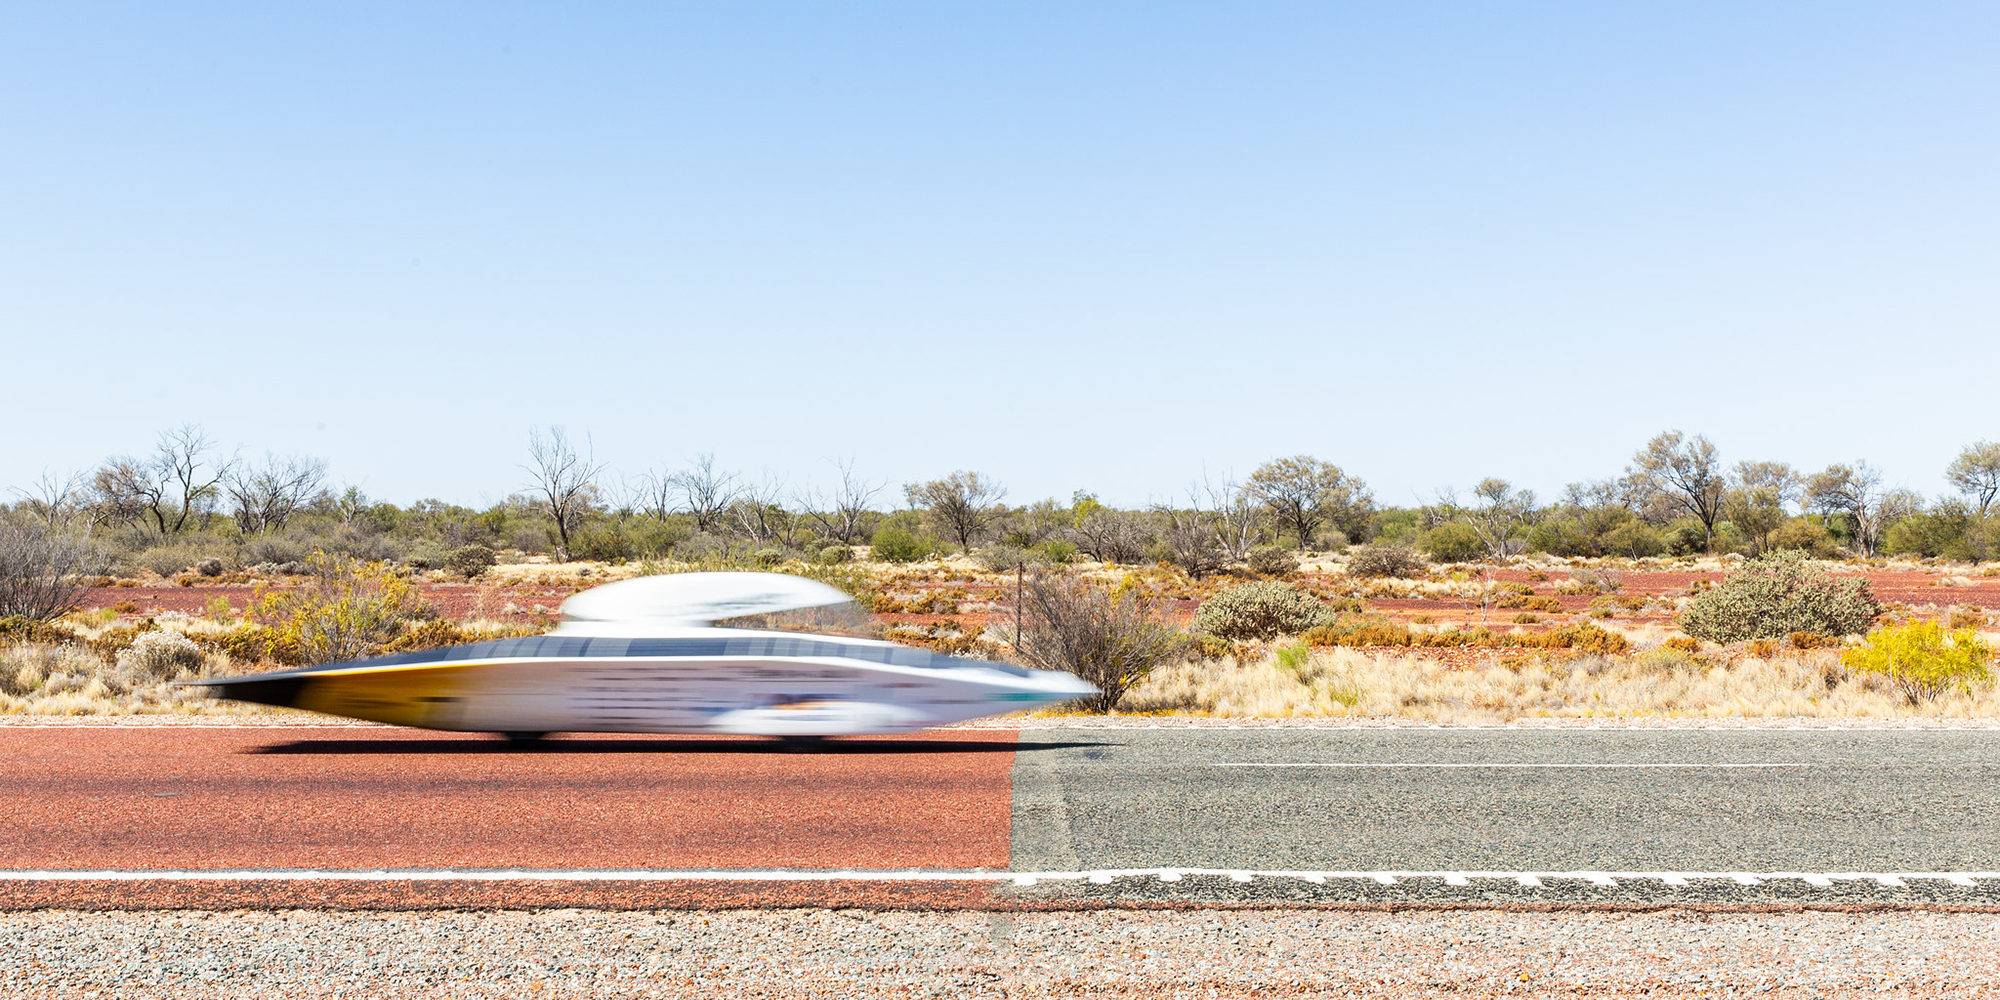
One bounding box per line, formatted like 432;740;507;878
0;910;2000;998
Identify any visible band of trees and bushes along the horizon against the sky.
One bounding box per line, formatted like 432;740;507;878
0;424;2000;576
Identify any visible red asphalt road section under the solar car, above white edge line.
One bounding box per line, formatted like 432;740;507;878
0;726;1014;870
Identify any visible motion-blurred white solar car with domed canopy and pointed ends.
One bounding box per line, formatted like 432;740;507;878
190;572;1096;740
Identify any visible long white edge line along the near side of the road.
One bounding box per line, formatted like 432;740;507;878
0;868;2000;888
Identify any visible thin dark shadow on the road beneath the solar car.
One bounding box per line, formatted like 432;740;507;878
242;736;1102;756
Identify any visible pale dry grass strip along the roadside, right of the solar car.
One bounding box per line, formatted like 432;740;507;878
1118;650;2000;724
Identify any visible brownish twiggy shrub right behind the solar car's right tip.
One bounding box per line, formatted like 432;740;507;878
1016;574;1186;712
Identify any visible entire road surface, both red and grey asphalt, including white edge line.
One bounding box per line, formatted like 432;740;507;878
11;726;2000;910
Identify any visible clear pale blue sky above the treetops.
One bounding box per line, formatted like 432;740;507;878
0;2;2000;504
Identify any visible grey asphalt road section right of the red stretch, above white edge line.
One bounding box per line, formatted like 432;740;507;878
1012;728;2000;872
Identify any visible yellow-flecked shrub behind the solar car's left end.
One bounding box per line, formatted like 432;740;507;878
252;556;430;664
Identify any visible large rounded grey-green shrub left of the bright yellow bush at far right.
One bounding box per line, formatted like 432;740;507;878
1680;552;1882;644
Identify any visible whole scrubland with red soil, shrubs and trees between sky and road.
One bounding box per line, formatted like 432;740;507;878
0;428;2000;722
